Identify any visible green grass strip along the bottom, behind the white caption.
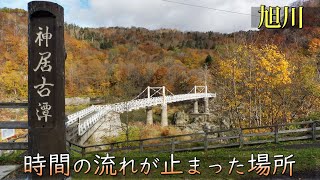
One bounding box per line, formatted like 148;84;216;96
0;141;320;179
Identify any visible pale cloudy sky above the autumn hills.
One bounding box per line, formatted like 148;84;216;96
0;0;295;33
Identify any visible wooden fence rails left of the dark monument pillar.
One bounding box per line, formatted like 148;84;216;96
0;103;28;150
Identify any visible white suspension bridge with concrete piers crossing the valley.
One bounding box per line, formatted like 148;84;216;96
66;86;216;143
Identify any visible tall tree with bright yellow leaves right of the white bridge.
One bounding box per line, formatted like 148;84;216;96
219;45;292;126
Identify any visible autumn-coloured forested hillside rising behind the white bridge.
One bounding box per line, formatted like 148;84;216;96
0;0;320;126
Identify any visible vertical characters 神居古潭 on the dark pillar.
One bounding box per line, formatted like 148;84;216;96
33;26;54;122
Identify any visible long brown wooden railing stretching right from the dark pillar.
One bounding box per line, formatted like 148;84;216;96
67;121;320;155
